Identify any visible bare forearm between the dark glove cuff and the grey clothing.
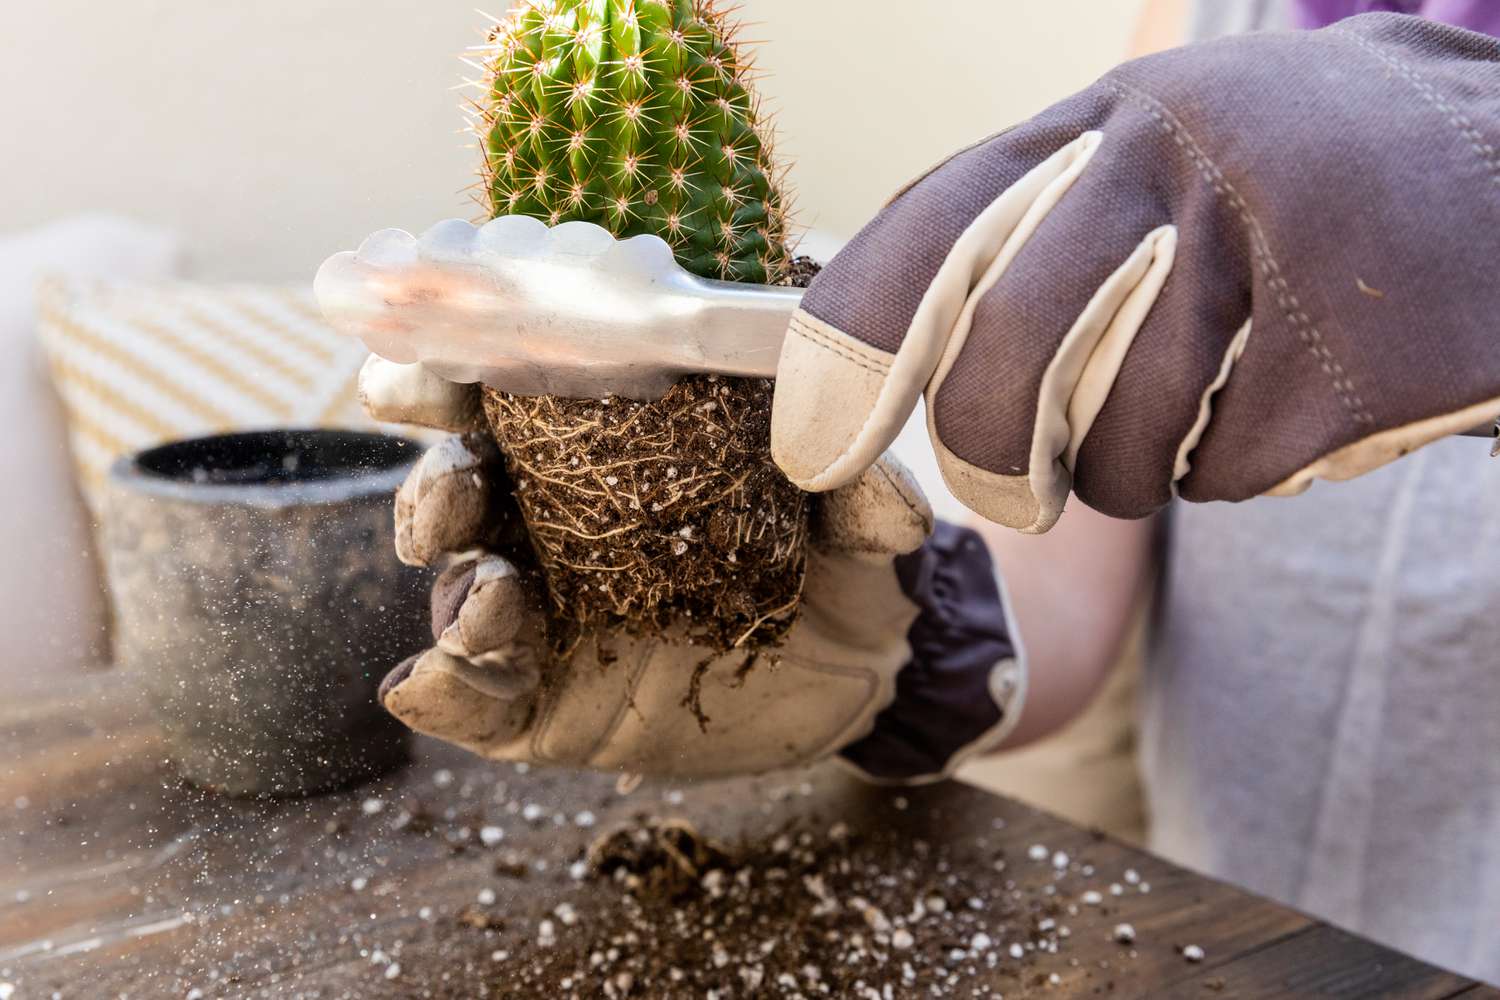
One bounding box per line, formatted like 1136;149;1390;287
972;502;1157;750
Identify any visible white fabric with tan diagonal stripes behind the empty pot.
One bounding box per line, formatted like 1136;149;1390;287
38;279;375;516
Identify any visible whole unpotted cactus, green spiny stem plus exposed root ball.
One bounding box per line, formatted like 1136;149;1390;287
471;0;807;663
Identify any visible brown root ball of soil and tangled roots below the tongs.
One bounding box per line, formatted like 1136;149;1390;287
485;258;818;652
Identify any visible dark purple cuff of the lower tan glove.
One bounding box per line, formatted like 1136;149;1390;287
840;522;1026;784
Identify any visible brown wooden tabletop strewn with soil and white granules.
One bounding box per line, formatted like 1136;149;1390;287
0;675;1500;1000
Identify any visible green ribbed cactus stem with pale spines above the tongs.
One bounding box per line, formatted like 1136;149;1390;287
471;0;788;283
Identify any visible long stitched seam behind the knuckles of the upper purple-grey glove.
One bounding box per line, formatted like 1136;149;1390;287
1110;79;1376;424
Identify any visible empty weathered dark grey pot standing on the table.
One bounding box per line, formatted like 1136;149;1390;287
105;430;432;795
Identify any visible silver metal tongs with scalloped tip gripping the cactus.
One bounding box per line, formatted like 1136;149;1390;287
315;216;803;399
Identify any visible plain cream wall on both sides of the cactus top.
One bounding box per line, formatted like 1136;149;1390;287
0;0;1140;279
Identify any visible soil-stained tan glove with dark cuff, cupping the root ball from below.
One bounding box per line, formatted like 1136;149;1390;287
362;358;1025;783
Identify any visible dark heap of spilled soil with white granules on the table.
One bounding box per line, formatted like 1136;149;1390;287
489;817;1092;1000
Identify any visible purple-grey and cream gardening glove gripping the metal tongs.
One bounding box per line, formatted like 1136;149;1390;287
773;13;1500;532
